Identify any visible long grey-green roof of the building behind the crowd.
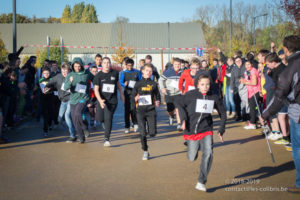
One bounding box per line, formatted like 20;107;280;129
0;23;206;54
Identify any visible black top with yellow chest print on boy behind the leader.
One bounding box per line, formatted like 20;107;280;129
132;78;160;112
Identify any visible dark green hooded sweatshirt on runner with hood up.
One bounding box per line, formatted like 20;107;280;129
64;58;90;104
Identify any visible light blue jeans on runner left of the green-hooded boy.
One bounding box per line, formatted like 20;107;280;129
58;101;75;138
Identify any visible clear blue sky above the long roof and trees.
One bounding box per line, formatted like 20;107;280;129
0;0;270;23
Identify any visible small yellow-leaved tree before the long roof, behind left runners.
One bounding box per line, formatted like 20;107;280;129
37;39;68;66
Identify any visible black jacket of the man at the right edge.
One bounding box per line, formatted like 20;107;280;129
262;51;300;123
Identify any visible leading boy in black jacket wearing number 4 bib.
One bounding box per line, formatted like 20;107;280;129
178;75;226;191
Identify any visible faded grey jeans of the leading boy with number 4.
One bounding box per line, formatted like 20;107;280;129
187;135;213;184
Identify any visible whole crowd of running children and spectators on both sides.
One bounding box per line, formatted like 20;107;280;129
0;36;300;192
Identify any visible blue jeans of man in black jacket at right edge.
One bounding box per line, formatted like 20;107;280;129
290;118;300;188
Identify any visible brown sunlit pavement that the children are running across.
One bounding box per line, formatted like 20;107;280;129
0;102;300;200
